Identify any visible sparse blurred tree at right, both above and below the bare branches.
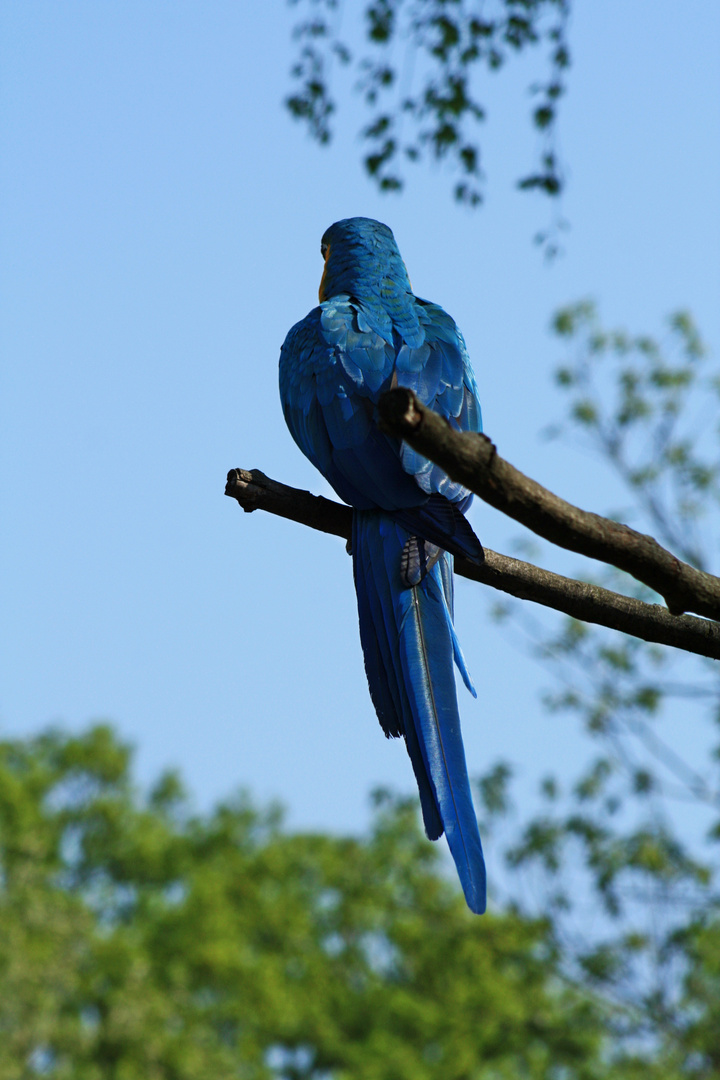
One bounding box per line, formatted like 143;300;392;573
490;301;720;1078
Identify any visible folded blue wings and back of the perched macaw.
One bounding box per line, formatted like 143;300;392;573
281;296;481;537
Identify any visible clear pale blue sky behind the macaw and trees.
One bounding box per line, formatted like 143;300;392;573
0;0;720;868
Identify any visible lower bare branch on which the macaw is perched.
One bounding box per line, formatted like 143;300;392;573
225;469;720;660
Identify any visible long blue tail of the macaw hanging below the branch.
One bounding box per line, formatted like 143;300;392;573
352;511;486;914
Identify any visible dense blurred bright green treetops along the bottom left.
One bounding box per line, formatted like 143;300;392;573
0;727;602;1080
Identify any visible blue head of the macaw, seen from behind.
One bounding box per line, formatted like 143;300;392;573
320;217;412;303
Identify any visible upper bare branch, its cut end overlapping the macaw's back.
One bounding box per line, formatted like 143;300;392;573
378;387;720;620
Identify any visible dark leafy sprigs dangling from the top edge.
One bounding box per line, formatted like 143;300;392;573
286;0;570;218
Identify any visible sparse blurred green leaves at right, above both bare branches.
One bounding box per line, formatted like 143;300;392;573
553;301;720;568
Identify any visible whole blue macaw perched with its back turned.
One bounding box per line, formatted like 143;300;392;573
280;217;486;913
